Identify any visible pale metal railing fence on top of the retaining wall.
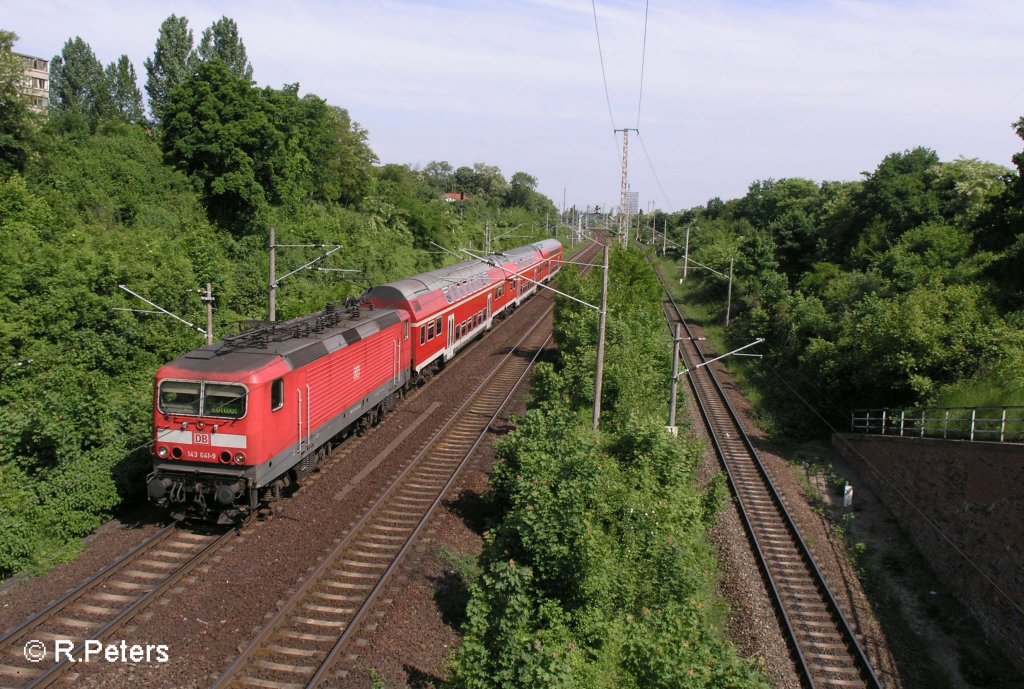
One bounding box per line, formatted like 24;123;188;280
850;406;1024;442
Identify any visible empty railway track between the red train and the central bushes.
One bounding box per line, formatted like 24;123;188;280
214;290;551;689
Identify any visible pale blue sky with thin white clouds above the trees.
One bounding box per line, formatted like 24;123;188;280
0;0;1024;211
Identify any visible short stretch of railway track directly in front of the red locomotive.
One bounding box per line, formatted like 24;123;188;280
0;524;237;689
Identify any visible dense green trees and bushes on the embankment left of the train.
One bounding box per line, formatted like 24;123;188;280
0;22;554;578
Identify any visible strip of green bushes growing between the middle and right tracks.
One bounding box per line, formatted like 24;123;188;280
449;252;769;689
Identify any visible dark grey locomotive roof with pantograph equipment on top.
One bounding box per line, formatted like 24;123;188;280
163;306;401;374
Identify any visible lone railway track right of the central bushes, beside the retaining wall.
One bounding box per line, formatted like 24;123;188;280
658;262;883;689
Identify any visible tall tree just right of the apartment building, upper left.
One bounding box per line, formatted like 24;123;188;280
50;36;114;130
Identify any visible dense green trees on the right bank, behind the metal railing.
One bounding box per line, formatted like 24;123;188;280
655;142;1024;435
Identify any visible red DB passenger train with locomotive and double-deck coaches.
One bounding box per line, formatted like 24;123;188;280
146;240;564;524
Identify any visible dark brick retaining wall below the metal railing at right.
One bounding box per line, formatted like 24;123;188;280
833;434;1024;670
